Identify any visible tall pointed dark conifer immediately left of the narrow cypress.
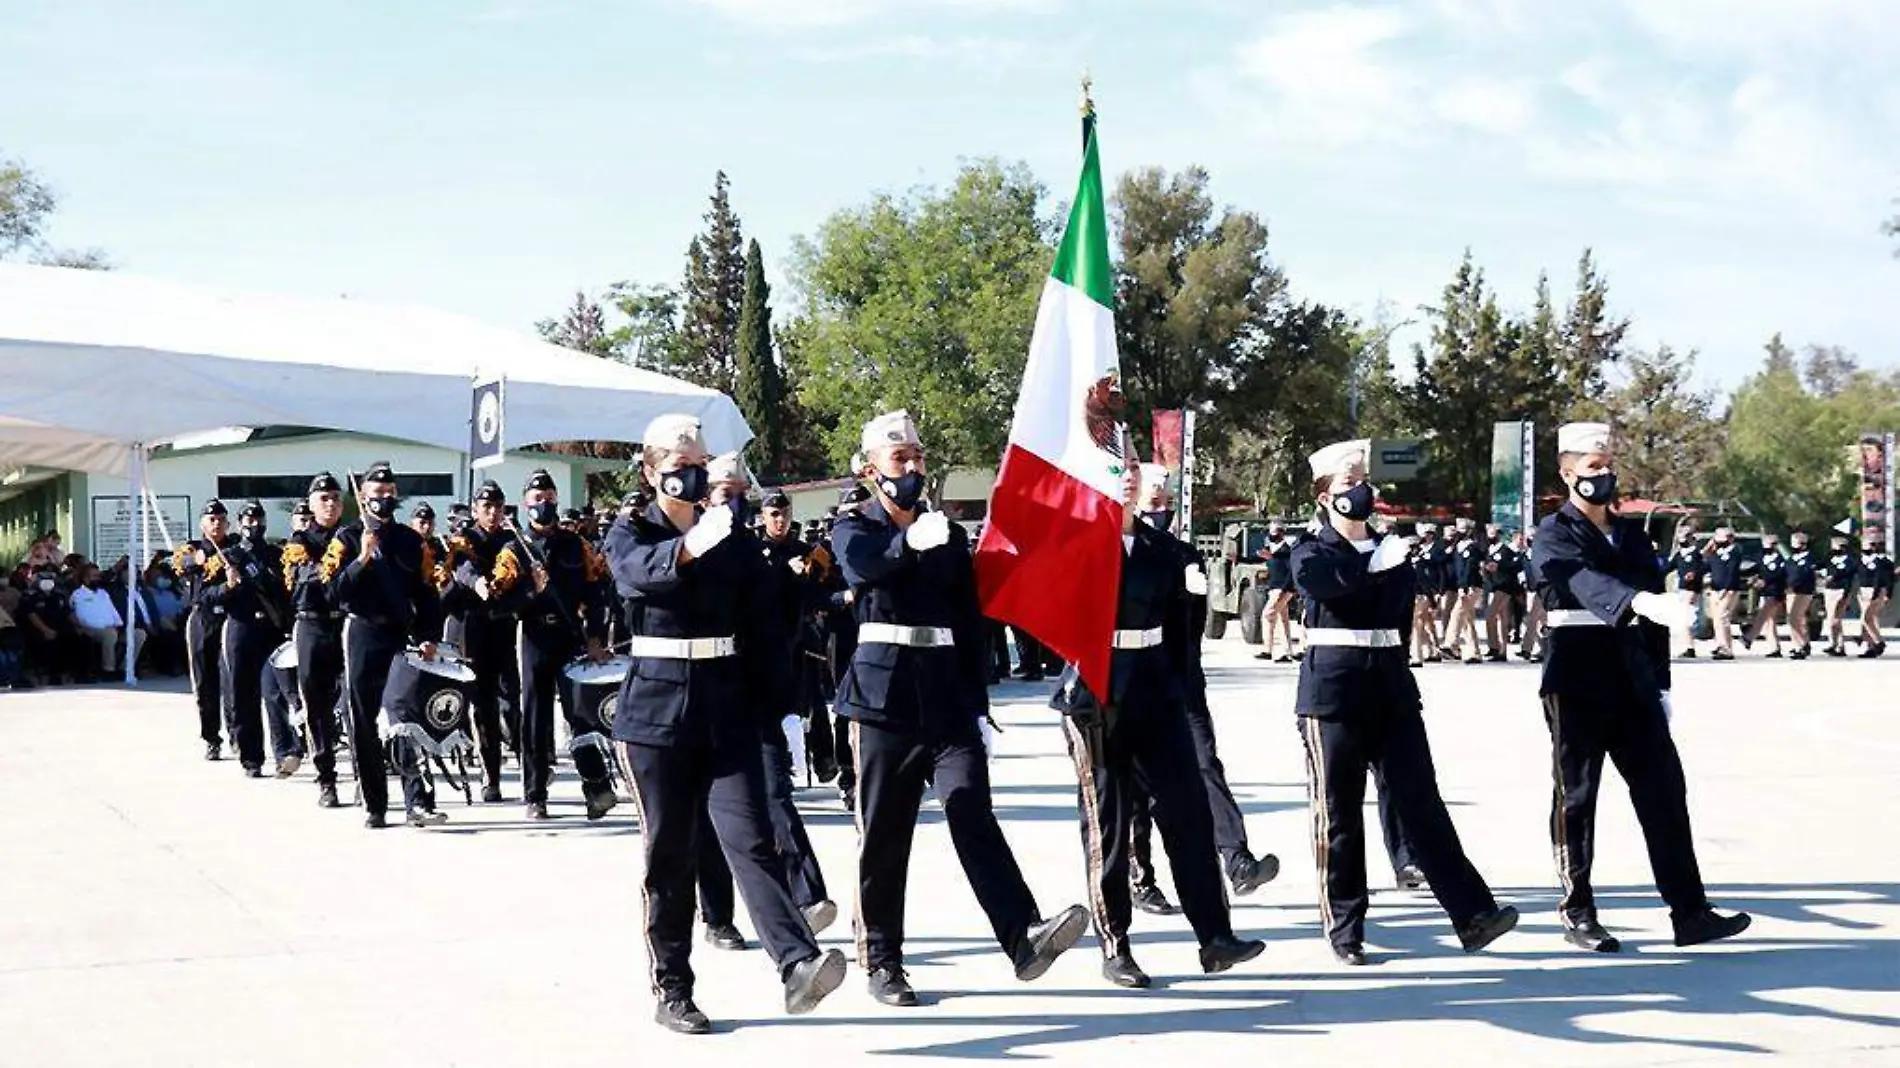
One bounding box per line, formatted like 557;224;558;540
671;171;745;393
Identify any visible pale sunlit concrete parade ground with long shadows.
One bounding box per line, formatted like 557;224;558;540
0;640;1900;1068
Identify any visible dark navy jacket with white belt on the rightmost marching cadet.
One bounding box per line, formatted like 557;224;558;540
1531;502;1670;697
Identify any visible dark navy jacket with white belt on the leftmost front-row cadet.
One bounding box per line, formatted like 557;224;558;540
606;504;787;747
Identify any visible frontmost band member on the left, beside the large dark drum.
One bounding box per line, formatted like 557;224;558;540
319;464;448;830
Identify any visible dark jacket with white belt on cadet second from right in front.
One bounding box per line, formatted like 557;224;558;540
1292;523;1419;720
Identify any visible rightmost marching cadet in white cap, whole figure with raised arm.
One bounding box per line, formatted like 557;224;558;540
1537;422;1748;952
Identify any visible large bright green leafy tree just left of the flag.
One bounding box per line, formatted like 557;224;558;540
785;160;1055;475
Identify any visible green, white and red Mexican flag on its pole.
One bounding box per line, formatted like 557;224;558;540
977;110;1131;696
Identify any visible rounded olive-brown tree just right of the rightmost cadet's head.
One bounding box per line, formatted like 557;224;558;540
1606;346;1721;500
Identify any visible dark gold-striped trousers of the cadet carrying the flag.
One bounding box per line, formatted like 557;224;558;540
1062;703;1233;956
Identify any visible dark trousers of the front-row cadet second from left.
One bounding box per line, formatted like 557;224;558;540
851;720;1039;971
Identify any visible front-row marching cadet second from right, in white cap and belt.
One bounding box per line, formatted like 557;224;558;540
1294;441;1518;965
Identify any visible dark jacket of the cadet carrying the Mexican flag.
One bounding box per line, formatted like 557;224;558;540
1049;523;1205;718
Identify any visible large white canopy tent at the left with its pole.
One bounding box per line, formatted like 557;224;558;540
0;264;752;682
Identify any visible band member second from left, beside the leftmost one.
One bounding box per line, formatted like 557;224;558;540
219;500;283;779
